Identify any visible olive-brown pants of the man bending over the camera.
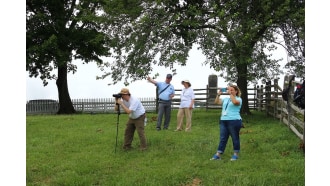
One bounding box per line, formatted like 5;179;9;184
123;114;147;150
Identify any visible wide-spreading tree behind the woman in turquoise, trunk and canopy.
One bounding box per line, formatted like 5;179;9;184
101;0;304;114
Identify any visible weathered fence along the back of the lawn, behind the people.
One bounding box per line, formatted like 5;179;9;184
26;86;257;114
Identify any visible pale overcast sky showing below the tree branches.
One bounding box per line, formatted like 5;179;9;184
26;44;287;101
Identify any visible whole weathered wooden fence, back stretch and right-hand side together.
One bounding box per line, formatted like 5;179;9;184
26;76;305;142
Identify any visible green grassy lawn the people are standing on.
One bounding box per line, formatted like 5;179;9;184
26;109;305;186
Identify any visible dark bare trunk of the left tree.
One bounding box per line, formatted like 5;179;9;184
56;63;76;114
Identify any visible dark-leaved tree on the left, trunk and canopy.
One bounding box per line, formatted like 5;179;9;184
26;0;110;114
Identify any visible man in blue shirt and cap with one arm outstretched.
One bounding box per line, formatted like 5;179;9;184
147;74;175;131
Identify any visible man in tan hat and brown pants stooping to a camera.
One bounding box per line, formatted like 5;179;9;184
113;88;147;150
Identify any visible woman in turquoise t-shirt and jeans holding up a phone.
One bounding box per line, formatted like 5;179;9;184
211;84;242;161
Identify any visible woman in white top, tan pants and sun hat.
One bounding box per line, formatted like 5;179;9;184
175;80;195;132
